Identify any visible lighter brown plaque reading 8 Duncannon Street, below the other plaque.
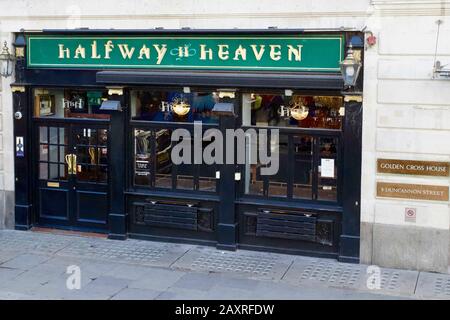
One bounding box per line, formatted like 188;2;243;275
377;182;449;201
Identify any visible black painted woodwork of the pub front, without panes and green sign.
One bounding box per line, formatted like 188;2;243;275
12;30;362;262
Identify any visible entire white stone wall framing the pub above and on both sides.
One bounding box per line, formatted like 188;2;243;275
0;0;450;270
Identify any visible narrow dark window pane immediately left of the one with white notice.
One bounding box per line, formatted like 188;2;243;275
292;136;313;199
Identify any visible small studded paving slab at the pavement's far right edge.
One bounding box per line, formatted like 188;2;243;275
415;272;450;300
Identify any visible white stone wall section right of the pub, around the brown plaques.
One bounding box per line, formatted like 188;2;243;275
361;0;450;271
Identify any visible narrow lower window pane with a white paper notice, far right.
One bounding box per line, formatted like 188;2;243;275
317;138;338;201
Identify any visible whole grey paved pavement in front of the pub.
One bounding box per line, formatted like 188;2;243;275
0;230;450;300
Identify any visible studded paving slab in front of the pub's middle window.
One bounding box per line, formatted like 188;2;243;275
172;247;294;279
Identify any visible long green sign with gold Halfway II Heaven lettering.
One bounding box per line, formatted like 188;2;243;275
27;35;344;72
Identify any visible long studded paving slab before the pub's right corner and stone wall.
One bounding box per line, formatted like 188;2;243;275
282;257;419;295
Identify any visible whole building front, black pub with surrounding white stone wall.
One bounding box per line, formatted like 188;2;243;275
0;0;450;272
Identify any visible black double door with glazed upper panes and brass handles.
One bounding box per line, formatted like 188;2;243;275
34;123;109;231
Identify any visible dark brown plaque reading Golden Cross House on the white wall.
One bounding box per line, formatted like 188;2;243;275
377;159;449;177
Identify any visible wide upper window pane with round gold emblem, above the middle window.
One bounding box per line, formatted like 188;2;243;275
131;90;219;123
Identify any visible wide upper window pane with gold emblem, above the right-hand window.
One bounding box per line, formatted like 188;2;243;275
242;93;344;129
